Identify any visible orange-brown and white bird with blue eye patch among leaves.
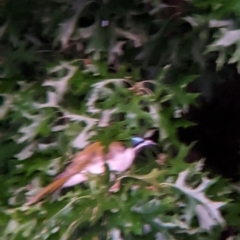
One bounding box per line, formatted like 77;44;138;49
26;136;156;206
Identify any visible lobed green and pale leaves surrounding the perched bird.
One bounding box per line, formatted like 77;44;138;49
0;0;240;240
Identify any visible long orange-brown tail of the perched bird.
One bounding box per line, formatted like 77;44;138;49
26;176;69;206
